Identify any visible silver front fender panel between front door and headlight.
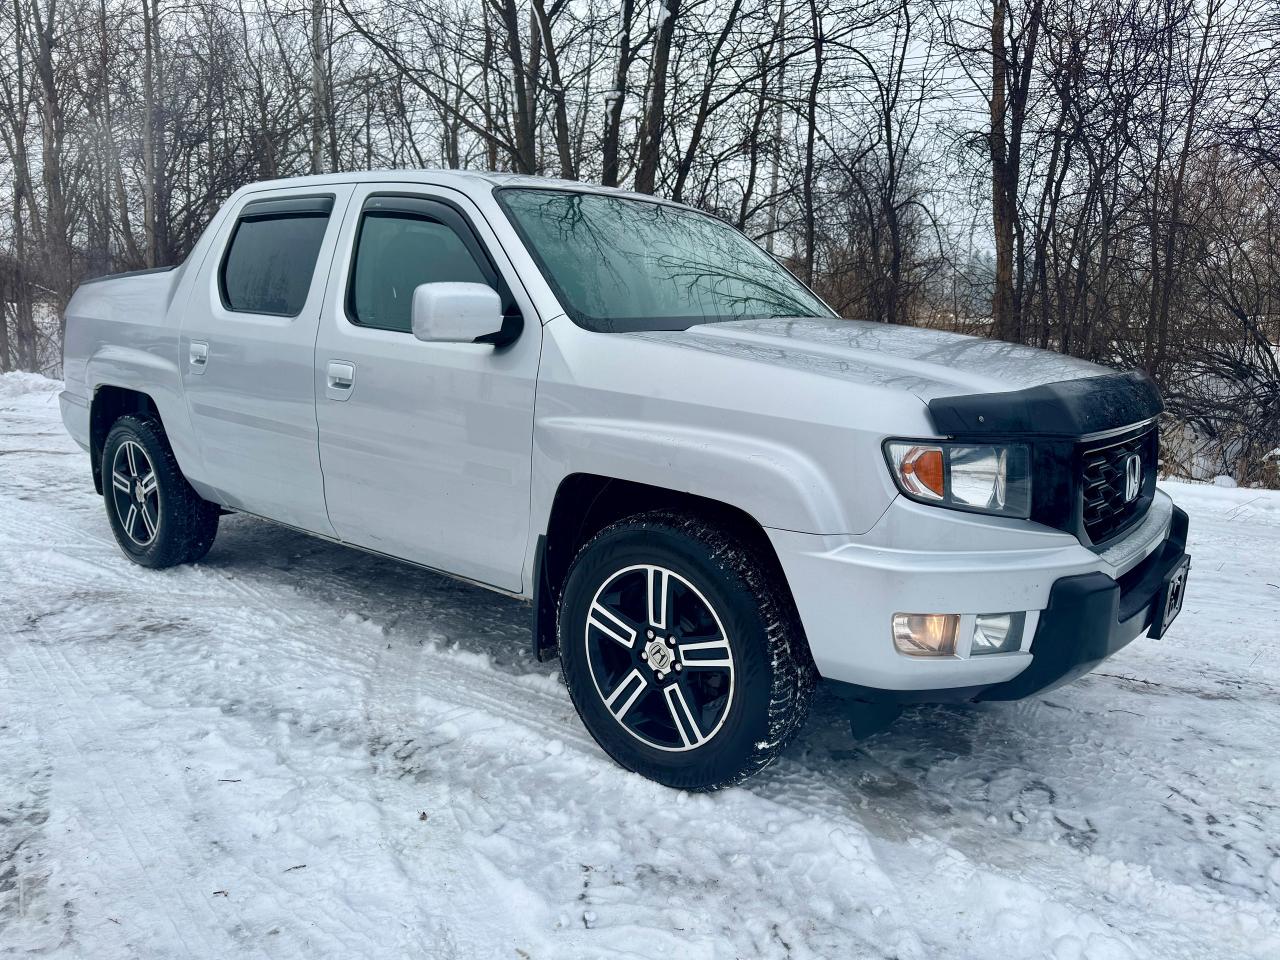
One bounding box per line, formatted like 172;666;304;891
525;317;932;585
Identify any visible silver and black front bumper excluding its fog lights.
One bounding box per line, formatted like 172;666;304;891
769;493;1187;703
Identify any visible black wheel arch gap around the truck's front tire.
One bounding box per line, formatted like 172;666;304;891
532;474;790;660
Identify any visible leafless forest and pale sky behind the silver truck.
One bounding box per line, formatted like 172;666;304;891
0;0;1280;485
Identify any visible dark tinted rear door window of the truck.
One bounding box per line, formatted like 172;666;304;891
219;197;333;316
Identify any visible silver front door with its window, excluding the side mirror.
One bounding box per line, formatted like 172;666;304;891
315;183;541;591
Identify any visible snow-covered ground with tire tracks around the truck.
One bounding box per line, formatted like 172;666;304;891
0;375;1280;960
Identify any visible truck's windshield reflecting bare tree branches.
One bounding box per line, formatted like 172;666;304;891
497;187;833;333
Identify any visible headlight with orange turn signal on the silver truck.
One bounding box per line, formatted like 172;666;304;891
884;440;1032;518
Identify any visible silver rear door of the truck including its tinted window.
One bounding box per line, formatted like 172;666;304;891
178;184;352;536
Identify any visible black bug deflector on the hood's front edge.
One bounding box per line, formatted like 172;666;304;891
929;370;1164;436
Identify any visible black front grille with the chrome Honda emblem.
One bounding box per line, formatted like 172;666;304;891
1080;424;1160;544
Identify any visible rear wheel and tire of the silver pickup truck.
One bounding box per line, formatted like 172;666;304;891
102;415;219;570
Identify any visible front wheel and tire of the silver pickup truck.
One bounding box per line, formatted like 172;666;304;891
557;511;817;791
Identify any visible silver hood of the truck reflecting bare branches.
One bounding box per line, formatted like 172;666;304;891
622;317;1114;402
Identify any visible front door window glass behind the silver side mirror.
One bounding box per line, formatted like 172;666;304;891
347;197;502;333
